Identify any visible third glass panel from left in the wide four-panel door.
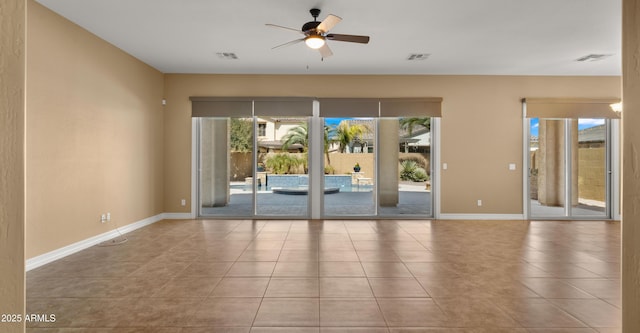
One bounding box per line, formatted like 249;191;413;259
324;118;376;216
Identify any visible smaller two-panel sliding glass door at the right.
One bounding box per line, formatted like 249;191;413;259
529;118;611;219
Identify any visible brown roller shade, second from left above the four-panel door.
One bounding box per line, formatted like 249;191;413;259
254;97;313;117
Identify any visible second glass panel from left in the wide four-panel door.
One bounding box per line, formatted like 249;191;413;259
255;116;310;217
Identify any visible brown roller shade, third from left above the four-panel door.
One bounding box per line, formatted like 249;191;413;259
318;98;380;118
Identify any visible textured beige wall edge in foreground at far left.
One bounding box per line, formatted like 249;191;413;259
0;0;25;333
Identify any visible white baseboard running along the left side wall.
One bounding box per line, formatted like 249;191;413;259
25;214;165;271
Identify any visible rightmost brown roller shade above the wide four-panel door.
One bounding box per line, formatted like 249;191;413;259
380;98;442;117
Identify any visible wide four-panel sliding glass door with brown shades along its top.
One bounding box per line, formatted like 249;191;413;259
192;97;441;219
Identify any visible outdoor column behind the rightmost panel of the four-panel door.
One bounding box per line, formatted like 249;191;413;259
377;118;400;207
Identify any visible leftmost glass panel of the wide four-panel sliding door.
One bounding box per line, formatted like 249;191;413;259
198;117;253;216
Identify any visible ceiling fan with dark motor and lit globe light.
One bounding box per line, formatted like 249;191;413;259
267;8;369;58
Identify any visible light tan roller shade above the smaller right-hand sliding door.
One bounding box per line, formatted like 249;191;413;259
522;98;620;119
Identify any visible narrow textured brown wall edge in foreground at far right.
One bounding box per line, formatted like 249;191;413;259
622;0;640;333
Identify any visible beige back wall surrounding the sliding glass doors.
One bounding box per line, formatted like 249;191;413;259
165;74;620;214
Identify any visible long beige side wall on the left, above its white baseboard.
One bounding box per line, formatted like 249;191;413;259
26;1;164;258
